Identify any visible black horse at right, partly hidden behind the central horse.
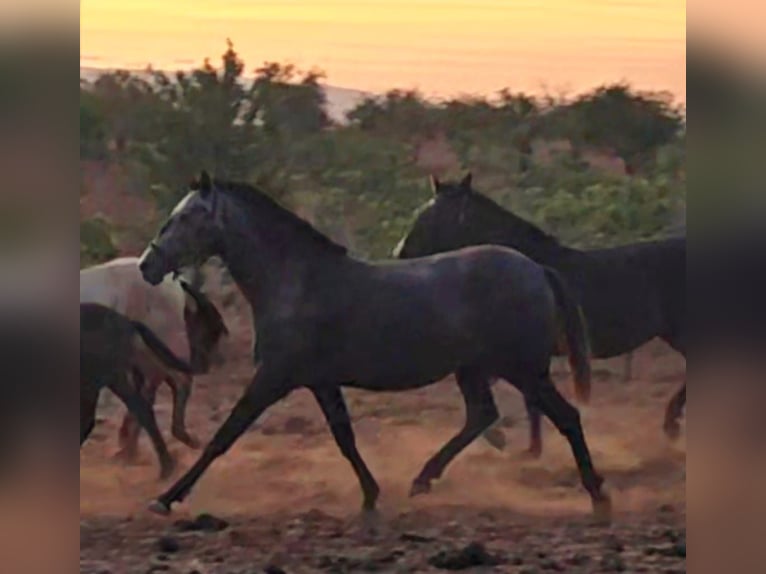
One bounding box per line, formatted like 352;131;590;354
393;172;688;456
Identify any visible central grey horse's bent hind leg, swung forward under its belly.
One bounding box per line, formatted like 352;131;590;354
410;369;499;496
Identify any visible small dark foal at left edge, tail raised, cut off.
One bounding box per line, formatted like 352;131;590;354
80;303;192;478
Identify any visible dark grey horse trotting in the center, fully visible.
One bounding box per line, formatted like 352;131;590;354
134;171;611;520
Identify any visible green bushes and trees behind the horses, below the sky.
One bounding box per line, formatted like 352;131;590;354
80;42;685;257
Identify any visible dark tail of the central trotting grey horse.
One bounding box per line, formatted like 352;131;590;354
544;267;591;403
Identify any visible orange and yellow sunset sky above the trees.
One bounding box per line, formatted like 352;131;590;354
80;0;686;101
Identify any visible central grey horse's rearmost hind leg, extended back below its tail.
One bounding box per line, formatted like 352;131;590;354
522;374;611;519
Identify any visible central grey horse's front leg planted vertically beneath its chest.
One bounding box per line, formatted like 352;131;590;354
311;387;380;510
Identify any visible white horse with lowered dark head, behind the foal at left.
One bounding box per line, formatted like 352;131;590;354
80;257;228;462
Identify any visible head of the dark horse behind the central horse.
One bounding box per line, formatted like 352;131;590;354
393;172;474;259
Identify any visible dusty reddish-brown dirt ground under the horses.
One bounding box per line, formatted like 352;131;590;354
80;317;686;574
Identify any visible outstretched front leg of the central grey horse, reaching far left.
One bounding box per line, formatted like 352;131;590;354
149;365;295;514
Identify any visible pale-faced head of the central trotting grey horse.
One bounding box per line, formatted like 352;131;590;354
139;171;219;285
